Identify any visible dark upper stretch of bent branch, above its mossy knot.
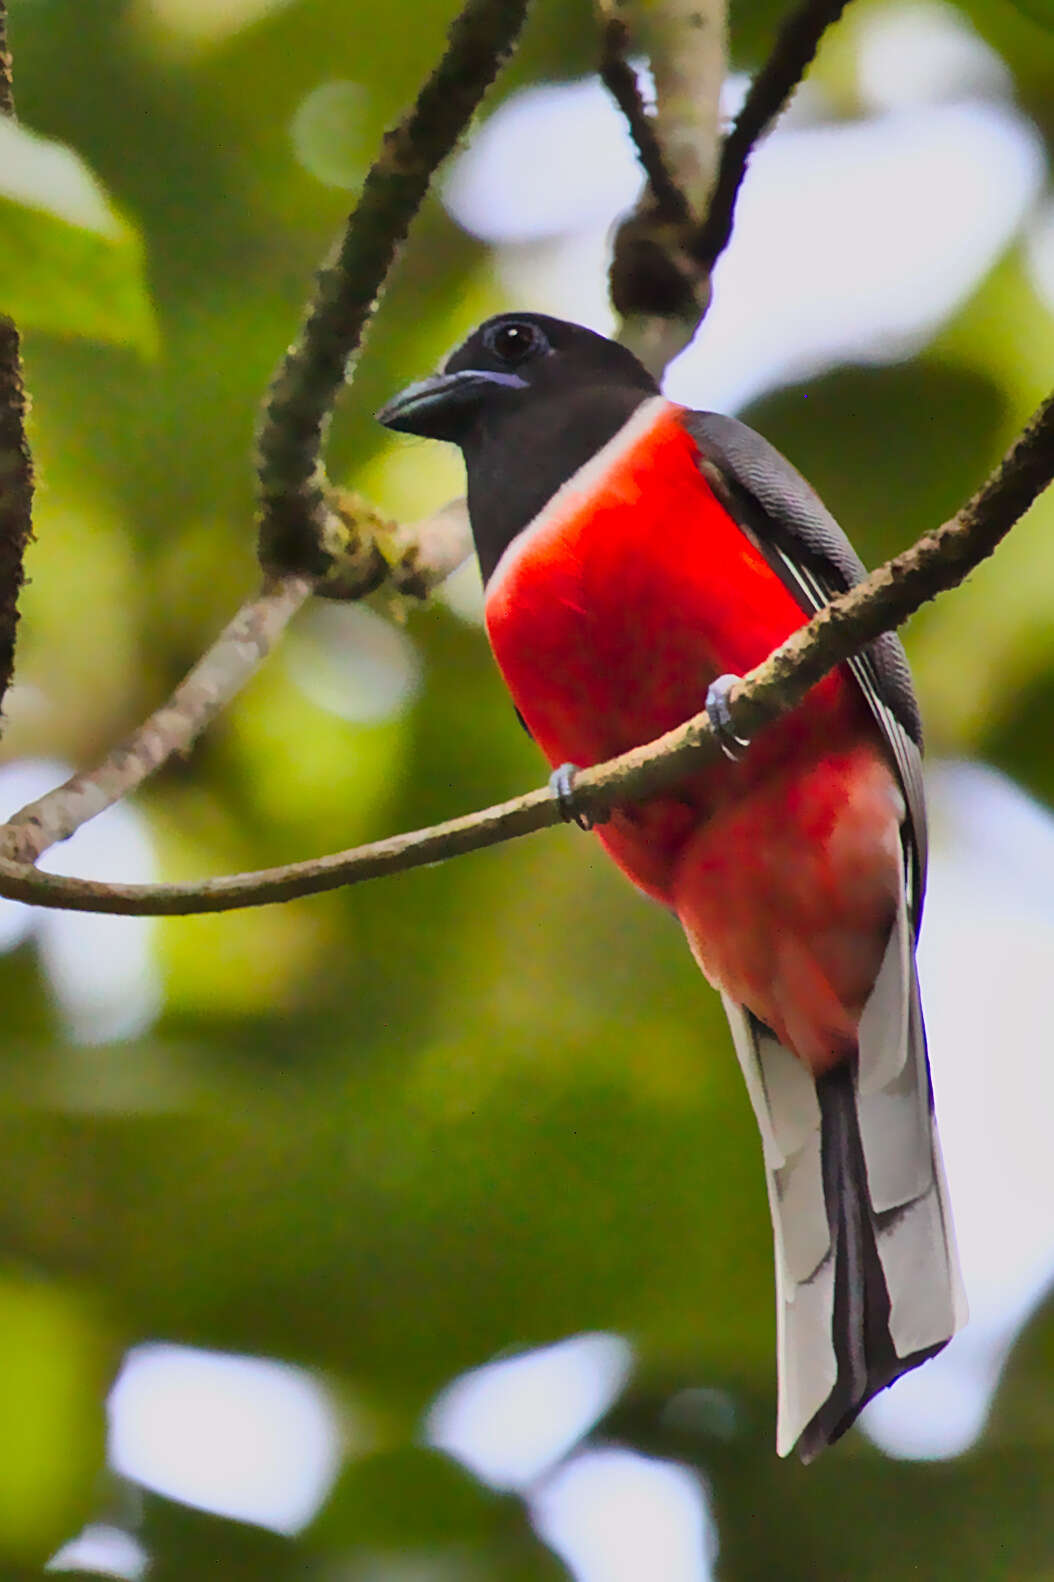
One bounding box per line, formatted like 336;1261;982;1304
258;0;529;581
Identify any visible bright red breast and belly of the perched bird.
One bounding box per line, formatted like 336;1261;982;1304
486;407;899;1068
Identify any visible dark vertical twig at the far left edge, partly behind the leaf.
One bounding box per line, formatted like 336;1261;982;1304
0;0;33;718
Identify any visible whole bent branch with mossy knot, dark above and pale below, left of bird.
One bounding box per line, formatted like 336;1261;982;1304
0;0;512;862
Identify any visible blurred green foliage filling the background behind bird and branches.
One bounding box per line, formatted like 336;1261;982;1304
0;0;1054;1582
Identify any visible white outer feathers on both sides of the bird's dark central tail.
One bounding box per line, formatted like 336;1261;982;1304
722;860;967;1455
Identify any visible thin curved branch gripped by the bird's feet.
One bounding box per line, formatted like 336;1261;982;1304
0;384;1054;916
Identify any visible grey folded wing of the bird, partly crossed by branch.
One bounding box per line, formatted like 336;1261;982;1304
684;411;927;933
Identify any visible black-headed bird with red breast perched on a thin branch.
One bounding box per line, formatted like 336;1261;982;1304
377;312;965;1462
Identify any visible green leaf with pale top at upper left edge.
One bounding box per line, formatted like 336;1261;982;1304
0;120;157;354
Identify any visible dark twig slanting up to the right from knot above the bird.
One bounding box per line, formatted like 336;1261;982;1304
692;0;848;271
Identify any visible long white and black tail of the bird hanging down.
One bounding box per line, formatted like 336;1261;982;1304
725;879;965;1462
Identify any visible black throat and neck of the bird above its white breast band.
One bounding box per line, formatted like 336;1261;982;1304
462;384;654;582
